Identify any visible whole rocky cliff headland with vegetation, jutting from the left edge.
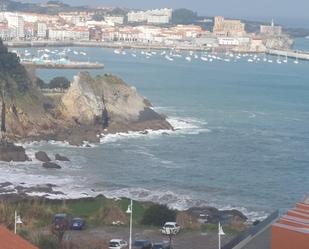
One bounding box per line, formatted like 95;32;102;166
0;39;172;144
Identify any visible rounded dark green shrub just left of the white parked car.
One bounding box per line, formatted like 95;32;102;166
141;204;176;226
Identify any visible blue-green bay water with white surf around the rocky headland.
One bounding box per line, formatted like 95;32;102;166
0;39;309;219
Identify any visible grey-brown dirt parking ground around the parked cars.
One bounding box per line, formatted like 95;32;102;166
63;227;232;249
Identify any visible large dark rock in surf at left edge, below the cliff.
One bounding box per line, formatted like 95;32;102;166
0;141;29;162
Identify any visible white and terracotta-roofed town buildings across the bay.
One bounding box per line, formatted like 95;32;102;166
0;2;293;53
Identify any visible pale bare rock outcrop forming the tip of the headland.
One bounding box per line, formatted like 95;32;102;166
61;72;172;135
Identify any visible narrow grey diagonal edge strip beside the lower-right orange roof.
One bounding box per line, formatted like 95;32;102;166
221;210;279;249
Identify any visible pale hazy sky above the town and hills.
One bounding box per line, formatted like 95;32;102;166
23;0;309;28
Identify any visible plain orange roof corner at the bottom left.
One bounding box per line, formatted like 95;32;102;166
0;226;38;249
